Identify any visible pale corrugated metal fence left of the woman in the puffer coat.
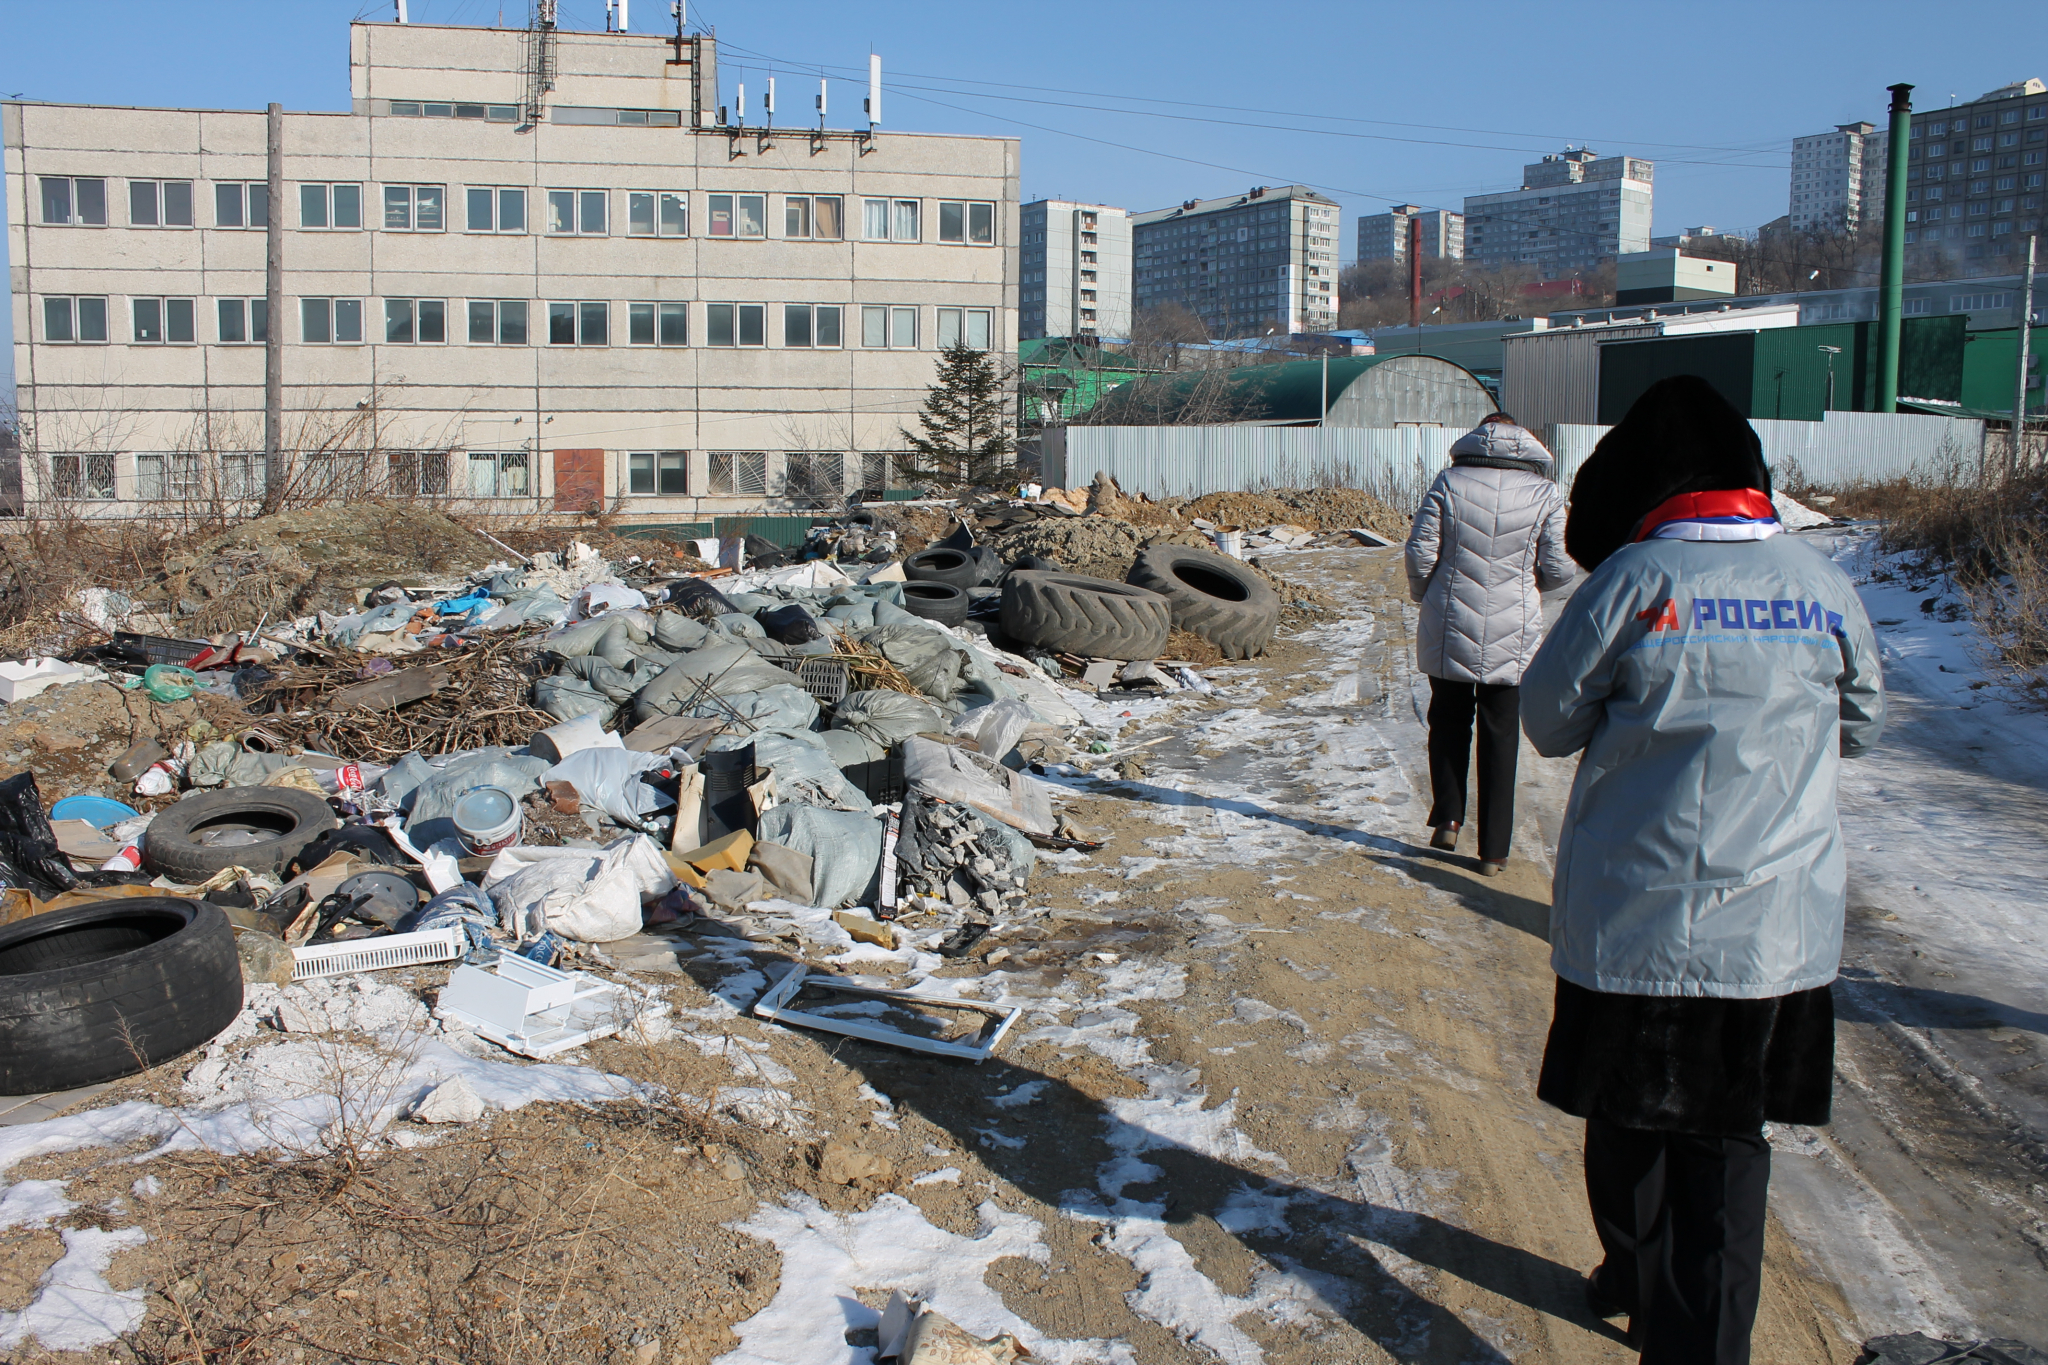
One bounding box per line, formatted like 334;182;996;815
1042;426;1462;508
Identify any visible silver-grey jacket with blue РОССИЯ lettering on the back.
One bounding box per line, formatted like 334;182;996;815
1522;534;1884;999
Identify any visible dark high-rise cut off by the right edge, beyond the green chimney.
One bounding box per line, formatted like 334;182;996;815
1907;80;2048;278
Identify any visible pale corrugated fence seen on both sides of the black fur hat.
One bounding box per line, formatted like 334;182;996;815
1544;411;1985;489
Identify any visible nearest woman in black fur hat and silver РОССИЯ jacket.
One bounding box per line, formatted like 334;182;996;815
1522;375;1884;1365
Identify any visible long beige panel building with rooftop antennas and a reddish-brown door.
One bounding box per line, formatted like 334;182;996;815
0;23;1018;520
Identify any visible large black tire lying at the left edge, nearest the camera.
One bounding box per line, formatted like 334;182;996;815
0;896;242;1095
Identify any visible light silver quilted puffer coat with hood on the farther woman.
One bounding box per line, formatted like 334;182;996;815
1405;422;1575;684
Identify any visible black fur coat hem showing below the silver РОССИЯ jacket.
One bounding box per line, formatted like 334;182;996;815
1536;978;1835;1138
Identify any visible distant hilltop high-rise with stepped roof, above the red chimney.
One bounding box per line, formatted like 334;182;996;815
1464;147;1657;278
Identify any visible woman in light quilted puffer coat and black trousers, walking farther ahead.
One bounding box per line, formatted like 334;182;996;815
1407;413;1573;876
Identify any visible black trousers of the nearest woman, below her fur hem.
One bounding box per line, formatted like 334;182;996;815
1585;1119;1772;1365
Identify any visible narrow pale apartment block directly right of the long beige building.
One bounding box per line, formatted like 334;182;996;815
1018;199;1130;340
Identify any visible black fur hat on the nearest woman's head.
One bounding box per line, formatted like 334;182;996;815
1565;375;1772;569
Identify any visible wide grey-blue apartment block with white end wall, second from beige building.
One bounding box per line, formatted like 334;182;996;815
1130;184;1339;338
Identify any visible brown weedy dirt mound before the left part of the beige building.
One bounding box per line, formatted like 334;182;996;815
137;503;510;634
